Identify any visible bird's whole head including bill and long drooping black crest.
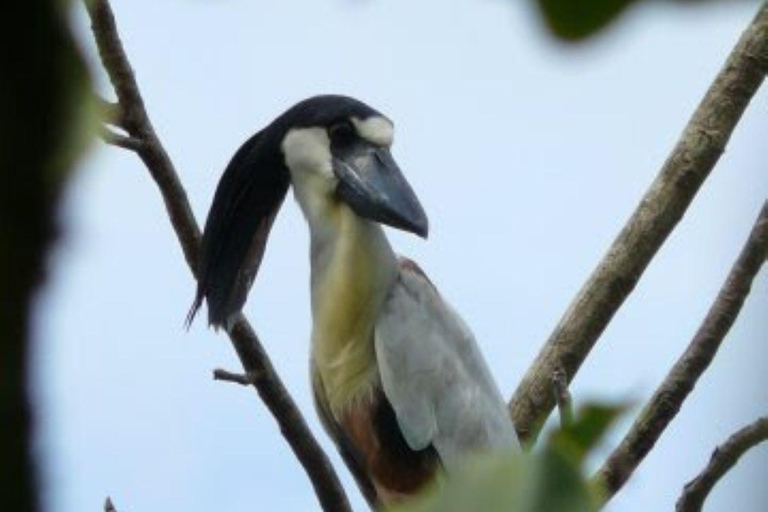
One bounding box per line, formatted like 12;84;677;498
188;96;428;326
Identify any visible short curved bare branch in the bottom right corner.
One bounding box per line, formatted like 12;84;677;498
675;417;768;512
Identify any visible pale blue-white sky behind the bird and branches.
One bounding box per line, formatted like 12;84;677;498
35;0;768;512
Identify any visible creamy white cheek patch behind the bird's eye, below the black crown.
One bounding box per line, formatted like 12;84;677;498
280;128;333;177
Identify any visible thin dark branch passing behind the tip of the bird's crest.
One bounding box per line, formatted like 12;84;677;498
85;0;351;512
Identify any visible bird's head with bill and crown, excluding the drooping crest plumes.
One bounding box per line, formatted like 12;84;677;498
274;96;428;237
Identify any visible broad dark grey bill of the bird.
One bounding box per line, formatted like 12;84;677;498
333;145;429;238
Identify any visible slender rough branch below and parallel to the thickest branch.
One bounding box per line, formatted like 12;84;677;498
595;202;768;501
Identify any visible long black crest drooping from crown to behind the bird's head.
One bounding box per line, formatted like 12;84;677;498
187;96;379;327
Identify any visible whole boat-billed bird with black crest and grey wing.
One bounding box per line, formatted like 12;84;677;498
188;95;519;508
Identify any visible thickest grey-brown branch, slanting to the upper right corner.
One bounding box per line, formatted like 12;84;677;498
509;4;768;443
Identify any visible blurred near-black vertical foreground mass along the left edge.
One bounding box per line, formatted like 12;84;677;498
0;0;92;512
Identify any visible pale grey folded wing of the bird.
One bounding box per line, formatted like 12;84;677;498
375;259;517;468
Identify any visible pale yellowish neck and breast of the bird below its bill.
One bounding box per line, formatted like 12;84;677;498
296;176;397;412
